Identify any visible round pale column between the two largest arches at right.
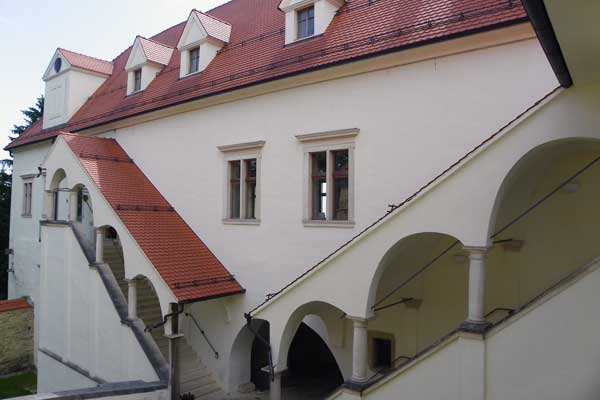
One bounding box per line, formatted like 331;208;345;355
465;247;488;325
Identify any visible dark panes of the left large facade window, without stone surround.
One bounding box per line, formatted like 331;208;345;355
227;158;257;220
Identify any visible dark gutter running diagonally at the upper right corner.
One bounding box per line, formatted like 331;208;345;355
522;0;573;88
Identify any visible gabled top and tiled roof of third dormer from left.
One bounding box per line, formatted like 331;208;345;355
177;9;231;49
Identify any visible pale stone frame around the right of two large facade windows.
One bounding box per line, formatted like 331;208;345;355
296;128;360;228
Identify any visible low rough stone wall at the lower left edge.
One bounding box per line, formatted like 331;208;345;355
0;299;33;375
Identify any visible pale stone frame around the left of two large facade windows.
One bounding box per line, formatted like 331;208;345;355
218;140;265;225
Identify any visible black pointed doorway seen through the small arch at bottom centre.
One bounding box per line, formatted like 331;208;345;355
283;322;344;399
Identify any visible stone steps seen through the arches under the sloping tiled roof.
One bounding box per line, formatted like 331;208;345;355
104;239;228;400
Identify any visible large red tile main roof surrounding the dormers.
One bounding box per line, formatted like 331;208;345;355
7;0;527;149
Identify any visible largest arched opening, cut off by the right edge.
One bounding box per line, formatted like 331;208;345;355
486;139;600;318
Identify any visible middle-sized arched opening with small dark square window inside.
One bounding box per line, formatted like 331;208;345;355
369;232;468;364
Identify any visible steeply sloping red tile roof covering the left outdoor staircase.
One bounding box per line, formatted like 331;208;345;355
61;133;244;302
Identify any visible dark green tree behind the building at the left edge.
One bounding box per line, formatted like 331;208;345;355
0;96;44;300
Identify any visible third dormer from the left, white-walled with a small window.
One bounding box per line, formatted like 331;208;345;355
177;10;231;78
